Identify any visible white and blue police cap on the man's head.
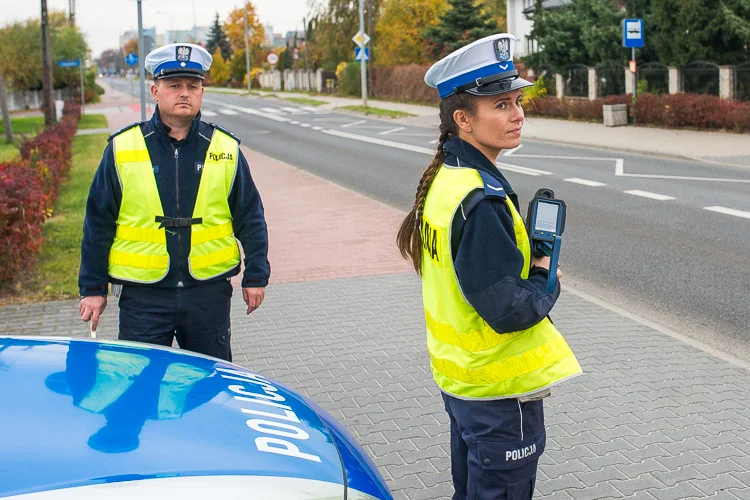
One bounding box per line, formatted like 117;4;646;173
143;43;213;80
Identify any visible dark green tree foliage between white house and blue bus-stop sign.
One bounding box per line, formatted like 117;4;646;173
524;0;628;72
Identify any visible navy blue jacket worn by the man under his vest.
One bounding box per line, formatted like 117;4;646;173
78;106;271;296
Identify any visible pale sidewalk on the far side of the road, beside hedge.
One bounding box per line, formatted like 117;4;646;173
250;87;750;163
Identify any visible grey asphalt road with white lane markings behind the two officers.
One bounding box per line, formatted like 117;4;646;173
110;80;750;361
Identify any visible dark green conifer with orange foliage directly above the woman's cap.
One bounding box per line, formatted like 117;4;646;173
425;0;499;59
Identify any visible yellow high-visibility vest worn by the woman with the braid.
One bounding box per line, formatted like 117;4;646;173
421;165;581;399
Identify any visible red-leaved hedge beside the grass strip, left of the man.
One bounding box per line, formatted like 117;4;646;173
0;103;81;282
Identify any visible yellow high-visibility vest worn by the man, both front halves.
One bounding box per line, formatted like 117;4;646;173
109;126;240;283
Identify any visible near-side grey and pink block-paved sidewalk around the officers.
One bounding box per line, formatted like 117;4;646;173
0;145;750;500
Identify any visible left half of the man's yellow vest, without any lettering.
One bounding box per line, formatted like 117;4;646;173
109;127;169;283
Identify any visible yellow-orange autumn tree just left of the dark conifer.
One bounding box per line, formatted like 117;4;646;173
375;0;448;66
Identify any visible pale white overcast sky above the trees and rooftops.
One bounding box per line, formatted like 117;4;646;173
0;0;310;57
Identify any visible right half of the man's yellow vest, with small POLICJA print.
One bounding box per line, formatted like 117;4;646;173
188;130;240;280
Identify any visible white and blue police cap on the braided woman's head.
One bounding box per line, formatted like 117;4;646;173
424;33;533;99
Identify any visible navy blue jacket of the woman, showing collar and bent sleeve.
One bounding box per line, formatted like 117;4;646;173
444;137;560;333
